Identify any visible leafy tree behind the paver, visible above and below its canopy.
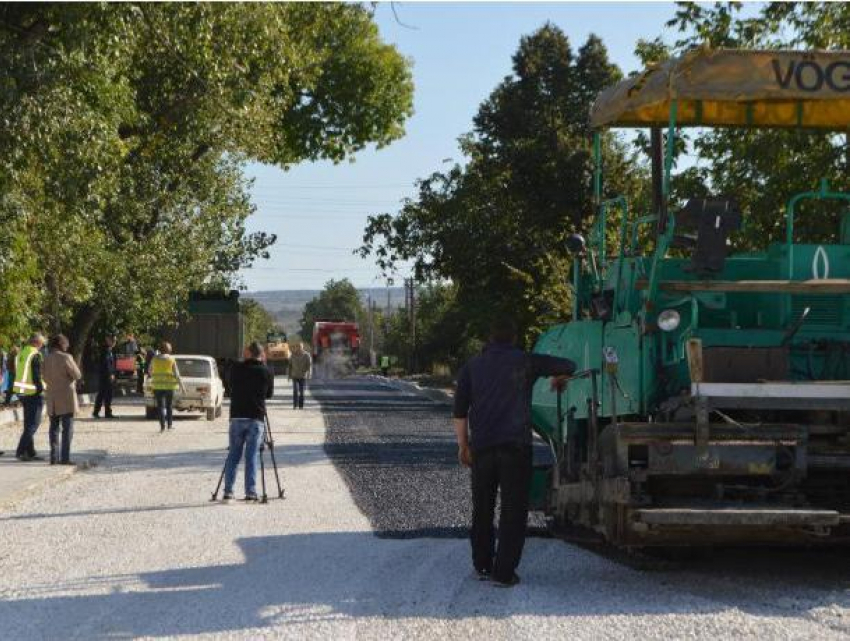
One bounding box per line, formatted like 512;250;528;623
644;2;850;250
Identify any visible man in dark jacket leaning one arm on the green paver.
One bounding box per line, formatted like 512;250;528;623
454;318;575;587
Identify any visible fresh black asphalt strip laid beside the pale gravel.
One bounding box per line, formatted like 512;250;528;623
310;378;470;538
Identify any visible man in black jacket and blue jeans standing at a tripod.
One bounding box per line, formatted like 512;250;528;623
223;342;274;501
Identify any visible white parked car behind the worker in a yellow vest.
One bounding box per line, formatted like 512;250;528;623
145;354;224;421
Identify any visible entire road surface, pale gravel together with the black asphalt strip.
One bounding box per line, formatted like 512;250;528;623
0;372;850;641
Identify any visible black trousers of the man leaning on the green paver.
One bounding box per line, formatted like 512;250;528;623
470;444;532;581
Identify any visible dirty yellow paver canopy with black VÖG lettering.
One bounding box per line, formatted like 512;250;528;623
590;48;850;131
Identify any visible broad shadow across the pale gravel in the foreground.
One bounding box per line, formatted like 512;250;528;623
6;532;850;639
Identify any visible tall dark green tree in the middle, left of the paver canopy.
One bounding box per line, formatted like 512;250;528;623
361;24;639;344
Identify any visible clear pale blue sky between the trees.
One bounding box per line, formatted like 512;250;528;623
243;2;696;291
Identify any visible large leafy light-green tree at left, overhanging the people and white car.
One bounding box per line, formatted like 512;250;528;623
0;3;412;354
